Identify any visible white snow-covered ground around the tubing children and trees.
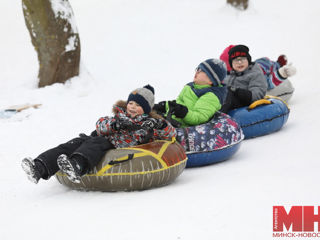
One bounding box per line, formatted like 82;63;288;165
0;0;320;240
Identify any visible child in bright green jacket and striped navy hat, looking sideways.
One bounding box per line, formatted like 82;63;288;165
154;59;227;127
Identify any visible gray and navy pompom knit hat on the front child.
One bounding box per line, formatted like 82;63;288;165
127;84;154;114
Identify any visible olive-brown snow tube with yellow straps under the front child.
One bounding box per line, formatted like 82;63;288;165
56;139;187;191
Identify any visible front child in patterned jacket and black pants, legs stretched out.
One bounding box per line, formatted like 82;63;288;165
21;85;176;183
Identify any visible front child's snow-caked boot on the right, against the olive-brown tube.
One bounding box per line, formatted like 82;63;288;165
57;154;82;183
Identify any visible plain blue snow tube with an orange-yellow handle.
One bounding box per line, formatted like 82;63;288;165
228;96;290;139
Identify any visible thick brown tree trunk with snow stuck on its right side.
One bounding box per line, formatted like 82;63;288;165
22;0;80;87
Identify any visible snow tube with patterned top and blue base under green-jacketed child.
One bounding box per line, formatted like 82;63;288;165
177;112;244;167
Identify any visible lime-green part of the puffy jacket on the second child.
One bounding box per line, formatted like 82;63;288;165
166;84;221;127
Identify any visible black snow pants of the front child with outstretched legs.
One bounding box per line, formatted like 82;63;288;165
35;134;114;179
